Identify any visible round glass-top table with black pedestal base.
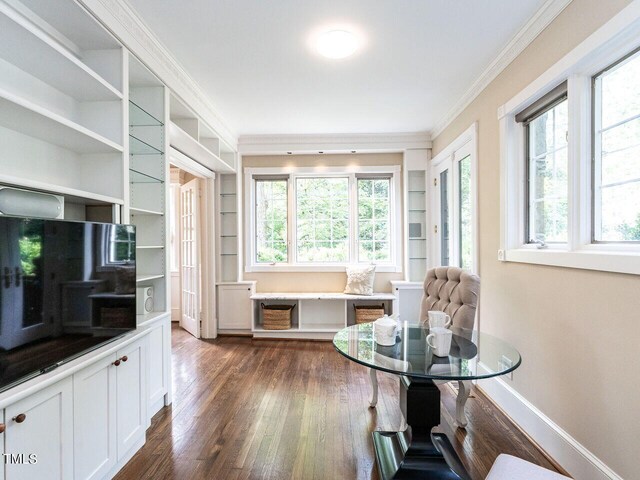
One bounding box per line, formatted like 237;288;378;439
333;322;522;480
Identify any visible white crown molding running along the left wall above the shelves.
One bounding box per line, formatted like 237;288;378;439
78;0;238;149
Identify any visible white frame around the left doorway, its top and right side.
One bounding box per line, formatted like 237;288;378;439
169;147;218;338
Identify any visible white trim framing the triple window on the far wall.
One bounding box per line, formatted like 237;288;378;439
243;165;403;273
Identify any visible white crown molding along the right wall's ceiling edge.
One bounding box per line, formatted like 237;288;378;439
431;0;572;138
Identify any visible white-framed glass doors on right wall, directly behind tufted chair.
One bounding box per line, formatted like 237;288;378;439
428;123;478;272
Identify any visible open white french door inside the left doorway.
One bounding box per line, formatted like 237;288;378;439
180;178;200;338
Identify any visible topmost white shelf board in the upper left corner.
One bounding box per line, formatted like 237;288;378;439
0;2;122;102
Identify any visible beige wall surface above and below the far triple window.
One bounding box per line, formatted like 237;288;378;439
242;153;404;292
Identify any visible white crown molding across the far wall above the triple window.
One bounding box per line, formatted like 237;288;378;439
238;132;431;155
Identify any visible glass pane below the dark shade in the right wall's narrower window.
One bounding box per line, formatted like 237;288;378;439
527;100;569;243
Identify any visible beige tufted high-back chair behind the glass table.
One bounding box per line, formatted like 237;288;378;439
369;267;480;427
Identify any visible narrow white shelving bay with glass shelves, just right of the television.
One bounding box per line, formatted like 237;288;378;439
128;58;169;323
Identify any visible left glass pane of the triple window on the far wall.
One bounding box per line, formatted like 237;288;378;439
256;180;288;263
